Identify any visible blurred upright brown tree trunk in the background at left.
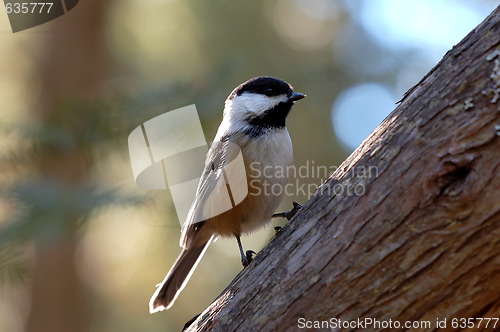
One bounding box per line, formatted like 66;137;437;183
26;0;110;332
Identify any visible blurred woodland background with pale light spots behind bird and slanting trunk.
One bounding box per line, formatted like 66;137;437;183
0;0;498;332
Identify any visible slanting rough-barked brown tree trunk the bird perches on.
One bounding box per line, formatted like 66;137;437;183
189;7;500;331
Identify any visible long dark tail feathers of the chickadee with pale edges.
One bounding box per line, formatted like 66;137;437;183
149;236;213;314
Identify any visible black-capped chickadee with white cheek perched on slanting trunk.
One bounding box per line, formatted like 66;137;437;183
149;76;306;314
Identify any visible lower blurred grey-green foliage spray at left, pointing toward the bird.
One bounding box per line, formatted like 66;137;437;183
0;179;147;243
